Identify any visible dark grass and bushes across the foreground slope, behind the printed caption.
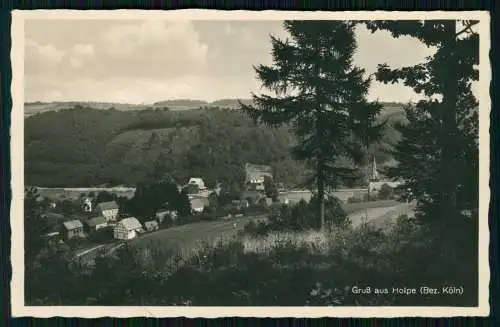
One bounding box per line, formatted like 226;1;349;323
26;218;477;306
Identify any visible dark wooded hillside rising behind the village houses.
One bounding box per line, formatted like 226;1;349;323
25;106;402;187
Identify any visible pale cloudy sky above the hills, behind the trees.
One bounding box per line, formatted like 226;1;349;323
25;20;434;103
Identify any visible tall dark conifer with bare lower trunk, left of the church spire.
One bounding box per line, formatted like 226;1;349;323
241;21;383;228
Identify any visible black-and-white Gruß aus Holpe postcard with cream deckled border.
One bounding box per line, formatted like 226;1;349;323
11;10;491;317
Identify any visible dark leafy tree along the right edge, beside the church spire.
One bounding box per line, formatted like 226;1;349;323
367;20;479;234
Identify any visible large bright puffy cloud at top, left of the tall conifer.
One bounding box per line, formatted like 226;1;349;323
97;20;208;77
